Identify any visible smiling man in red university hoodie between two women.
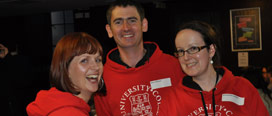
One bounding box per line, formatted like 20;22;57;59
94;0;184;116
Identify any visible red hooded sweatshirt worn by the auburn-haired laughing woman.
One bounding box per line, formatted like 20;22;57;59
26;87;90;116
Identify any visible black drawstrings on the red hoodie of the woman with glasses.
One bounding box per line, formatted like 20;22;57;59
199;72;219;116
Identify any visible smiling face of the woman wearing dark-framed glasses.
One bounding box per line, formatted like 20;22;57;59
175;29;215;77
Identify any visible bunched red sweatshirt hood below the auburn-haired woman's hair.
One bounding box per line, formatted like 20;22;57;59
26;87;90;116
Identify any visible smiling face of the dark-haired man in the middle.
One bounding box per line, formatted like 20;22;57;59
106;6;147;48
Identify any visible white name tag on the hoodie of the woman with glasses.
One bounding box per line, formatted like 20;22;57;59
222;94;245;106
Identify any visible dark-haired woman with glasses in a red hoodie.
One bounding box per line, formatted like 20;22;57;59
159;21;269;116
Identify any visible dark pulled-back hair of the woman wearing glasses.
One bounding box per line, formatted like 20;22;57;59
177;21;221;67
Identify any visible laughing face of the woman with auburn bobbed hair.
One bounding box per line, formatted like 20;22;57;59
68;52;103;94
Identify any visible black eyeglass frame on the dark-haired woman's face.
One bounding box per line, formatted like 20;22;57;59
174;45;209;58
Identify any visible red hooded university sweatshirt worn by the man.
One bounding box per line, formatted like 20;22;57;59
94;42;184;116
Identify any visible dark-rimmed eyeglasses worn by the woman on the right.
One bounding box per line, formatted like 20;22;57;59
174;46;208;57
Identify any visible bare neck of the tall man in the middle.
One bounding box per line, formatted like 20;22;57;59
119;46;146;67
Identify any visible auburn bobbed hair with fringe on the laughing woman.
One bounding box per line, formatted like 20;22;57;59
50;32;103;94
